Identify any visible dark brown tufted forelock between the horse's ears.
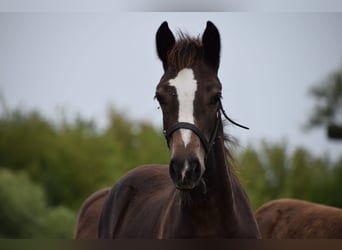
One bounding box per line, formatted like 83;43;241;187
168;31;203;71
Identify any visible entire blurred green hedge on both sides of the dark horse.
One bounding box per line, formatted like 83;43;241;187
0;104;342;238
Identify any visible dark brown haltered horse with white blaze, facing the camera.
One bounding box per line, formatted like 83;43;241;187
73;21;260;239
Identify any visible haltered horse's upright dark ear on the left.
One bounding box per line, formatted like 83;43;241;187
156;22;176;70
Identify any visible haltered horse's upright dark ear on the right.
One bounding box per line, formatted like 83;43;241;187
202;21;221;71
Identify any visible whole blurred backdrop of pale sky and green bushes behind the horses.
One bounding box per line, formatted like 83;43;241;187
0;0;342;238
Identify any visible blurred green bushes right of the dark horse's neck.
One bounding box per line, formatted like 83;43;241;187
237;142;342;209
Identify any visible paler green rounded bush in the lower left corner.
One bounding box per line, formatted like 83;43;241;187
0;168;75;238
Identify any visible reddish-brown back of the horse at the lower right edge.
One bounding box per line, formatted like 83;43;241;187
255;199;342;239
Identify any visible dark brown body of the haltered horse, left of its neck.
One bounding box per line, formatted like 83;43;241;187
99;165;173;239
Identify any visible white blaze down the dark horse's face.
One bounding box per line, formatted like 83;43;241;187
169;69;197;147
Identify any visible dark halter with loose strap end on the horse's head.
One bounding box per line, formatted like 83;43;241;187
163;101;249;158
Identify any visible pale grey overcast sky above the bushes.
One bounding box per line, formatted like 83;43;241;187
0;1;342;157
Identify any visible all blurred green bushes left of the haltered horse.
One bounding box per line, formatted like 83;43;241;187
0;106;168;238
